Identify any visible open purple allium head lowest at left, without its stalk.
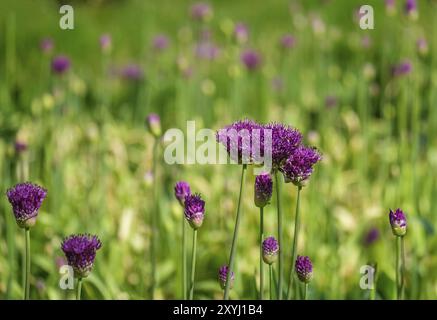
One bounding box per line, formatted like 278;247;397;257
61;234;102;278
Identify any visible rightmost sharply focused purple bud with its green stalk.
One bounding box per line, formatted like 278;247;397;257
389;209;407;300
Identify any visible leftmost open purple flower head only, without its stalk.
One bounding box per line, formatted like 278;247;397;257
6;182;47;229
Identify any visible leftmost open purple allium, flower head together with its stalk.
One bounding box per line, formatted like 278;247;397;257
6;182;47;300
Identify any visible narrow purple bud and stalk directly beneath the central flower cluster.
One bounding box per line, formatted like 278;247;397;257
254;173;273;300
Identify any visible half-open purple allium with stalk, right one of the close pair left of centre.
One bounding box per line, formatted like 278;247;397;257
184;194;205;300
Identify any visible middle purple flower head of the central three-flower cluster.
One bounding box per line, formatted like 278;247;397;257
264;122;302;170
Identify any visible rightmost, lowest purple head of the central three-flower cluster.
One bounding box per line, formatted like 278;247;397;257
281;145;322;187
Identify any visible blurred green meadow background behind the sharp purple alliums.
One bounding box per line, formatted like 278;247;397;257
0;0;437;299
